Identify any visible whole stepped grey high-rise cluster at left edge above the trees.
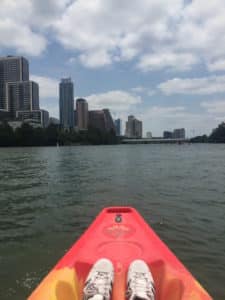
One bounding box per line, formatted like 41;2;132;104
0;56;45;126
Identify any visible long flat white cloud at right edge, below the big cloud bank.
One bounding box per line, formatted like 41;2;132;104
158;76;225;95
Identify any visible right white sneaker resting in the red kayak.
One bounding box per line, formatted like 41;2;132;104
127;260;155;300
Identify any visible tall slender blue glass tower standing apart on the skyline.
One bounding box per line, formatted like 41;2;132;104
59;78;74;129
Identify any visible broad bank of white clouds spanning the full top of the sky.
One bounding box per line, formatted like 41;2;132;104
0;0;225;72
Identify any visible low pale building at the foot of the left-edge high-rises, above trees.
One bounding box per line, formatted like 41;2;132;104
16;109;49;128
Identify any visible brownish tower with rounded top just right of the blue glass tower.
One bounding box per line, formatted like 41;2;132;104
76;98;88;130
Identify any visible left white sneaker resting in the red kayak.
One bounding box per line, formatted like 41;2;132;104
83;258;114;300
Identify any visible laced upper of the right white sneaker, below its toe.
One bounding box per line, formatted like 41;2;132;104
127;272;155;300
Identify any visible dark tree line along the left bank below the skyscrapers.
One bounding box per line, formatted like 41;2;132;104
0;122;119;147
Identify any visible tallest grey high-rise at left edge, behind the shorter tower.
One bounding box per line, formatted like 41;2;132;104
0;56;29;111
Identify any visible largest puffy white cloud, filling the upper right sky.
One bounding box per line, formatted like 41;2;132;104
50;0;225;71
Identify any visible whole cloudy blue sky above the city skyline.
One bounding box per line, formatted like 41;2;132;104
0;0;225;137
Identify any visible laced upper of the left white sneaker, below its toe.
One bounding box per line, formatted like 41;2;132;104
85;271;112;300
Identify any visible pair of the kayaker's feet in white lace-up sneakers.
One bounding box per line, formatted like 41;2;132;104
83;258;155;300
